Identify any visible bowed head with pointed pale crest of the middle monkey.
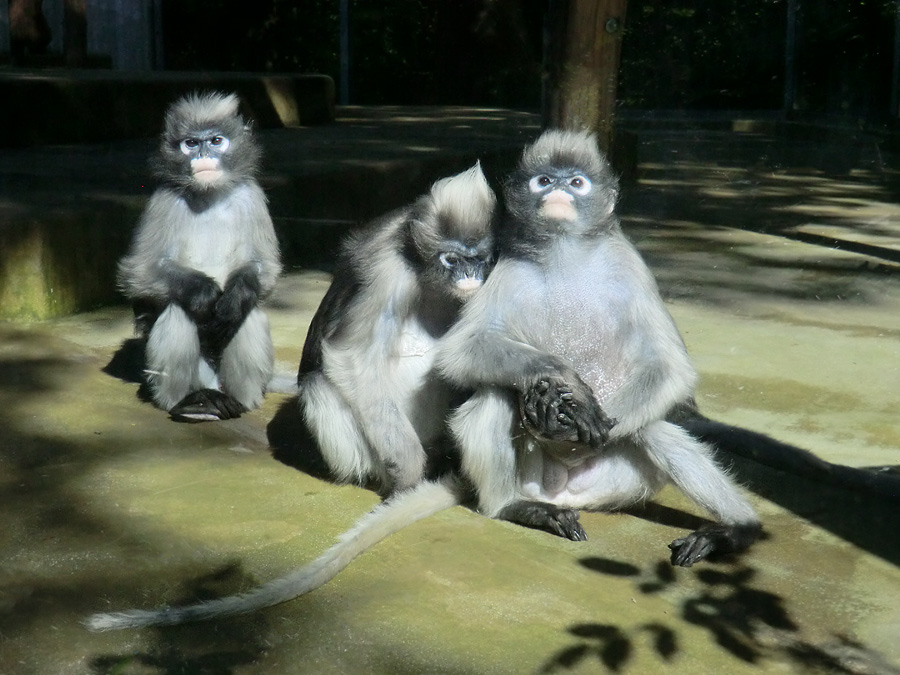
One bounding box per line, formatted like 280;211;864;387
407;164;497;302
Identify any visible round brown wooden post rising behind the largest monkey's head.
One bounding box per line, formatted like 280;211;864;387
543;0;628;151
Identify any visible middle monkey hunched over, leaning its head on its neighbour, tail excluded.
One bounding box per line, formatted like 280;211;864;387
298;164;496;494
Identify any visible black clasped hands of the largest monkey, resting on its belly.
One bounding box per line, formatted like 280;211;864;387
520;376;616;448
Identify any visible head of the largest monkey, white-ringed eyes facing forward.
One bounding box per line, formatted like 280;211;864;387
504;130;618;239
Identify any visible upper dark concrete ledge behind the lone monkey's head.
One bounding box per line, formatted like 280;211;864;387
0;70;334;147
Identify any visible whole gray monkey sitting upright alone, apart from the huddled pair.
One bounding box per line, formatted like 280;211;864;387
118;93;281;420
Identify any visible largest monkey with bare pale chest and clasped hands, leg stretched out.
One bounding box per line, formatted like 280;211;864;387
438;131;760;566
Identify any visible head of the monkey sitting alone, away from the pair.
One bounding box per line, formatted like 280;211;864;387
154;92;259;194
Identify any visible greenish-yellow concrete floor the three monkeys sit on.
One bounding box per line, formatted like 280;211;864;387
0;108;900;675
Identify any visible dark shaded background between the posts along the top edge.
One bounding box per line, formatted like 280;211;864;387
163;0;896;120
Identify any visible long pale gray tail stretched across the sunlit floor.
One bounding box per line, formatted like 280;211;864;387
84;478;461;631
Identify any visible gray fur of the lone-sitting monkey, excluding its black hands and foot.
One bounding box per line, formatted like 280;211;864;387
118;93;281;410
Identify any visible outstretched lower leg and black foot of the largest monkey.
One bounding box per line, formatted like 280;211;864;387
640;421;762;567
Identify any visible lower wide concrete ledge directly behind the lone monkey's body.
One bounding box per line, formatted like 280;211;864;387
0;108;538;320
